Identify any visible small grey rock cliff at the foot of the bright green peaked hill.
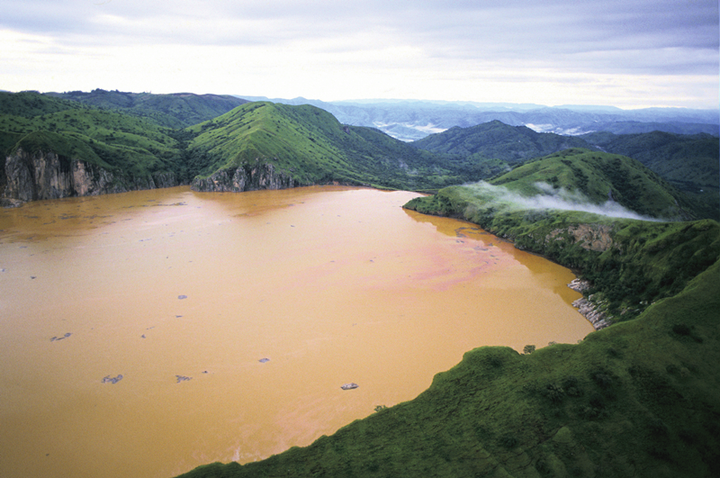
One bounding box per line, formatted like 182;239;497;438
192;163;301;192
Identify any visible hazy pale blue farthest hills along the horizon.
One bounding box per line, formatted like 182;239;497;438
241;96;720;141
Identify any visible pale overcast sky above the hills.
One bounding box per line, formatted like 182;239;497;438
0;0;720;109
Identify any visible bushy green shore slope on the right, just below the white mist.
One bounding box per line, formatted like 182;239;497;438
406;186;720;321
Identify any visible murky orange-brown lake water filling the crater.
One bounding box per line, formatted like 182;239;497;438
0;187;592;478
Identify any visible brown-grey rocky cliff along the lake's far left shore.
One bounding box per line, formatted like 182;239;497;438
0;149;178;207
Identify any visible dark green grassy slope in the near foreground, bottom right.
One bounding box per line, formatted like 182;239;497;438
177;263;720;478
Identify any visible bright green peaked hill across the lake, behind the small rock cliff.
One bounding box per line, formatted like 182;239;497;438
187;102;490;189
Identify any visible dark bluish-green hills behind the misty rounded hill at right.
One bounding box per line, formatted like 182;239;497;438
412;121;720;220
